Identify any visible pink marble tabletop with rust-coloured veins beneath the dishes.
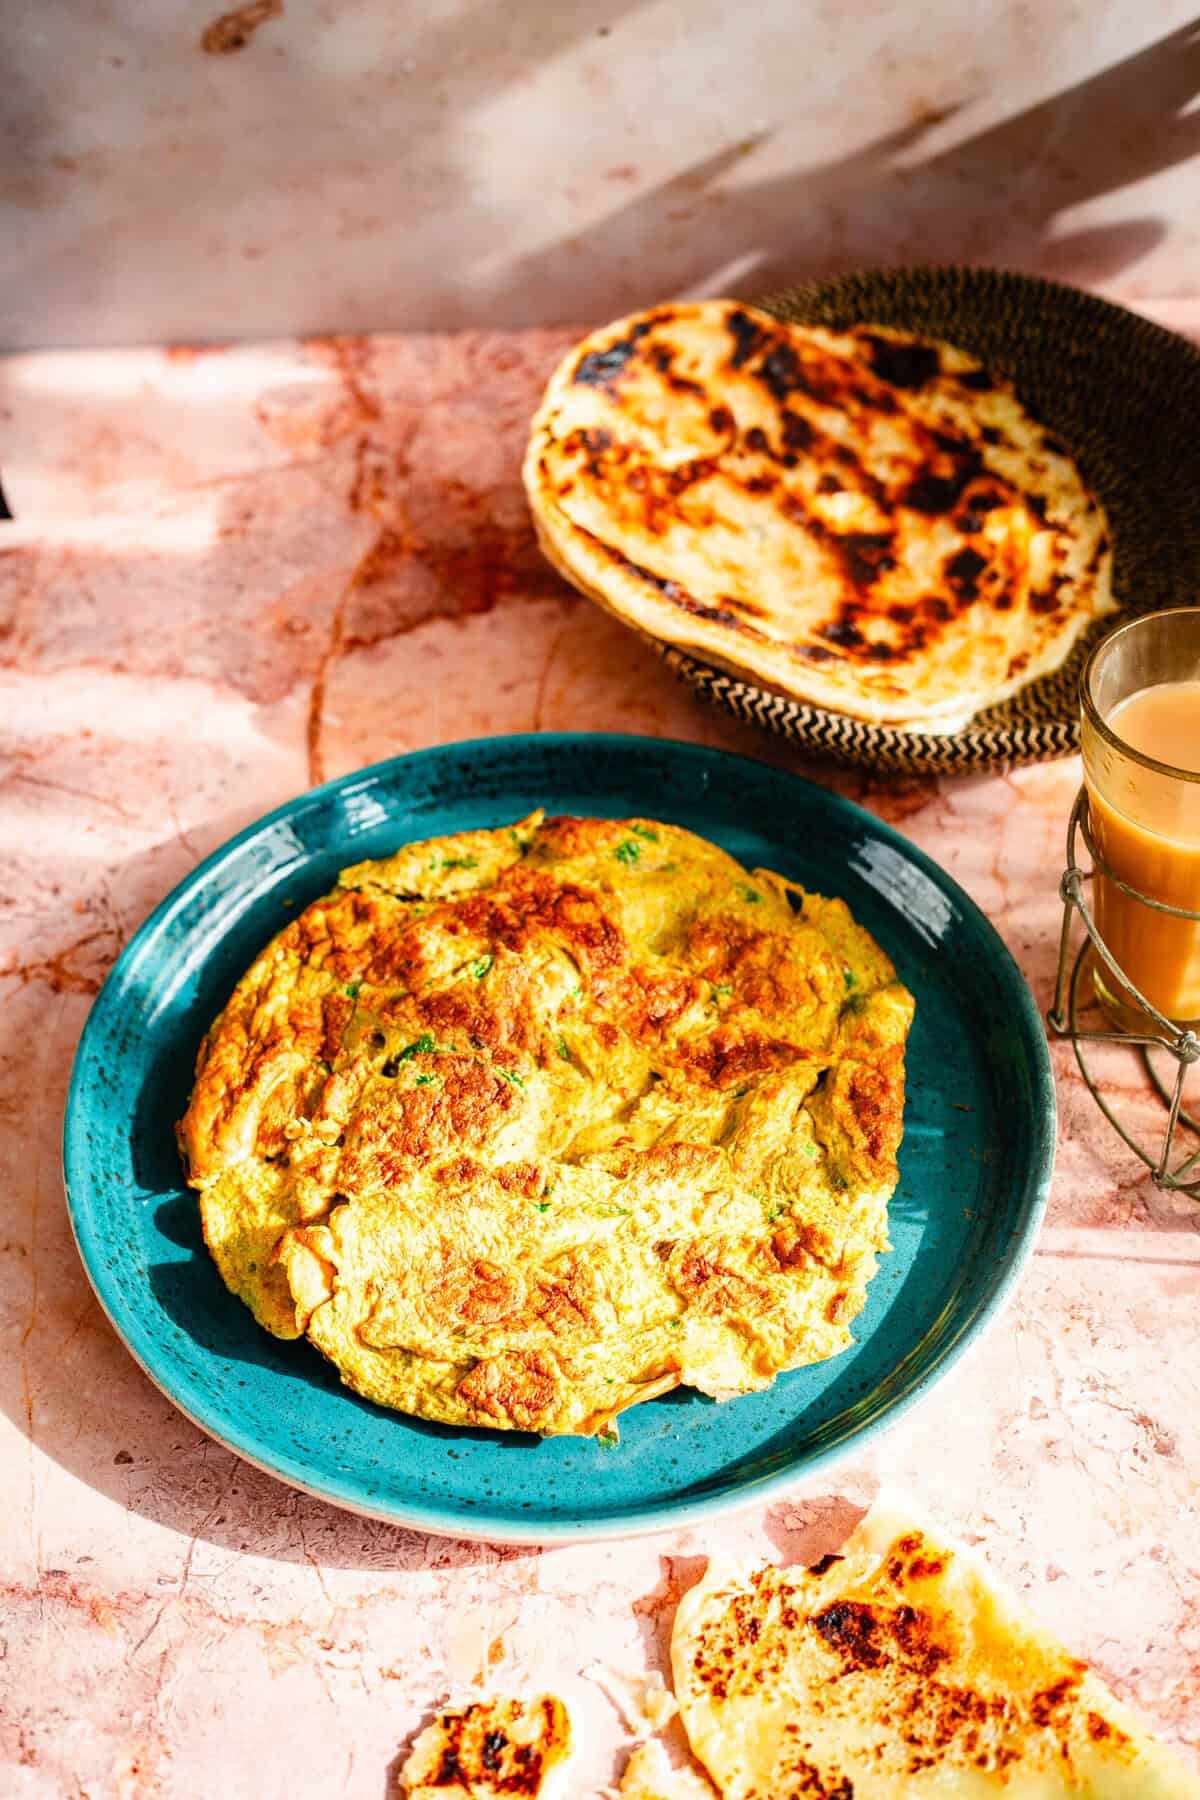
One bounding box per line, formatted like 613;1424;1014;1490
0;316;1200;1800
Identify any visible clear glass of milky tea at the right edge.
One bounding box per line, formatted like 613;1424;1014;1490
1081;607;1200;1031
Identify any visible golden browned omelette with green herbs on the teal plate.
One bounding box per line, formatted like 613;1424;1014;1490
180;814;912;1435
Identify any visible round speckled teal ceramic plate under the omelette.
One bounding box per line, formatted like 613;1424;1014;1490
65;734;1054;1543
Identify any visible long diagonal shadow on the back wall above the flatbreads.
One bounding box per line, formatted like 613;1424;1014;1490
474;23;1200;319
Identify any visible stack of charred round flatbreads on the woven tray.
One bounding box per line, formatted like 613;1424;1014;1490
525;301;1114;731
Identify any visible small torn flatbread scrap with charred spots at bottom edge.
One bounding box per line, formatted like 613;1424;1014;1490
401;1694;572;1800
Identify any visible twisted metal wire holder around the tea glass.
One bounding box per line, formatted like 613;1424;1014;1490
1045;787;1200;1199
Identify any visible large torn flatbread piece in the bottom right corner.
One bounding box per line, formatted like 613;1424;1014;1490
671;1508;1200;1800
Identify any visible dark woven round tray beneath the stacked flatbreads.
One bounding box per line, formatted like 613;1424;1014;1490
658;268;1200;770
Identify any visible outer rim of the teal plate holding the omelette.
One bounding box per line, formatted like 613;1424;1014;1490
61;731;1058;1544
